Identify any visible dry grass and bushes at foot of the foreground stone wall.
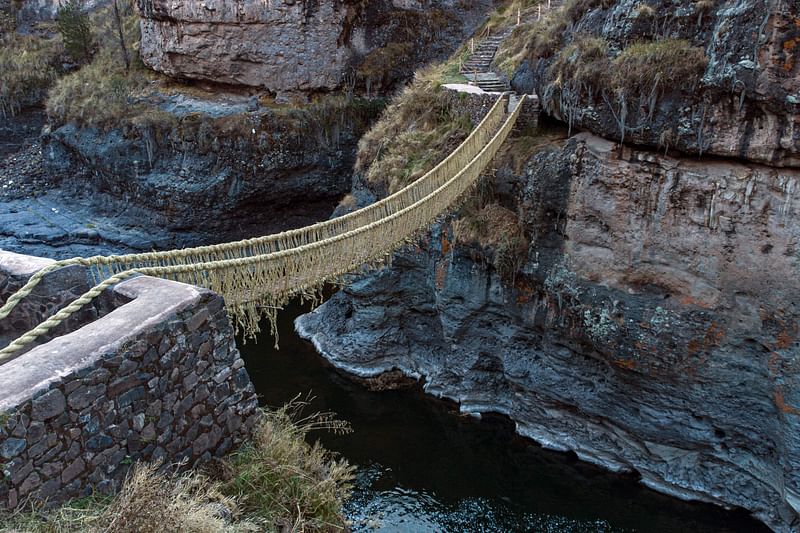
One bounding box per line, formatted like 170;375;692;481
0;401;353;533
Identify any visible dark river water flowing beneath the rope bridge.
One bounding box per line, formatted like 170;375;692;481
241;300;769;533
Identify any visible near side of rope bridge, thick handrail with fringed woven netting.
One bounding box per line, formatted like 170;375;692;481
0;97;524;362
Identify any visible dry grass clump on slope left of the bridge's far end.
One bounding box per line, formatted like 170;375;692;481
356;65;472;193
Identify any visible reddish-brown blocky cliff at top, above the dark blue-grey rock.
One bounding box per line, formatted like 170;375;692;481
138;0;492;95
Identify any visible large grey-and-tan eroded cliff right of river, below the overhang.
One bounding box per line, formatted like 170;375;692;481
297;134;800;532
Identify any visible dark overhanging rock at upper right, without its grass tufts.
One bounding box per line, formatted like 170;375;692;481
512;0;800;167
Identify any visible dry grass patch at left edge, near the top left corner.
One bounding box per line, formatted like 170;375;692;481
0;32;63;117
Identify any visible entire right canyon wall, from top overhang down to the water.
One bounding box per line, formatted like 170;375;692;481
296;0;800;532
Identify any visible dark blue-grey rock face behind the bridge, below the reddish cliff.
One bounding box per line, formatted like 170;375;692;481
37;97;382;245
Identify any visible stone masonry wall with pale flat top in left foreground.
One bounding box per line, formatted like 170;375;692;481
0;254;258;509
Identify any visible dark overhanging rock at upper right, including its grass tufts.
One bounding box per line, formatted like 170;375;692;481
512;0;800;166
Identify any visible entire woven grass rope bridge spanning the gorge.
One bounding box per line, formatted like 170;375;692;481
0;96;524;362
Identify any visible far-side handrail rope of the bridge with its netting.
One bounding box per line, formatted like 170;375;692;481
0;97;505;320
